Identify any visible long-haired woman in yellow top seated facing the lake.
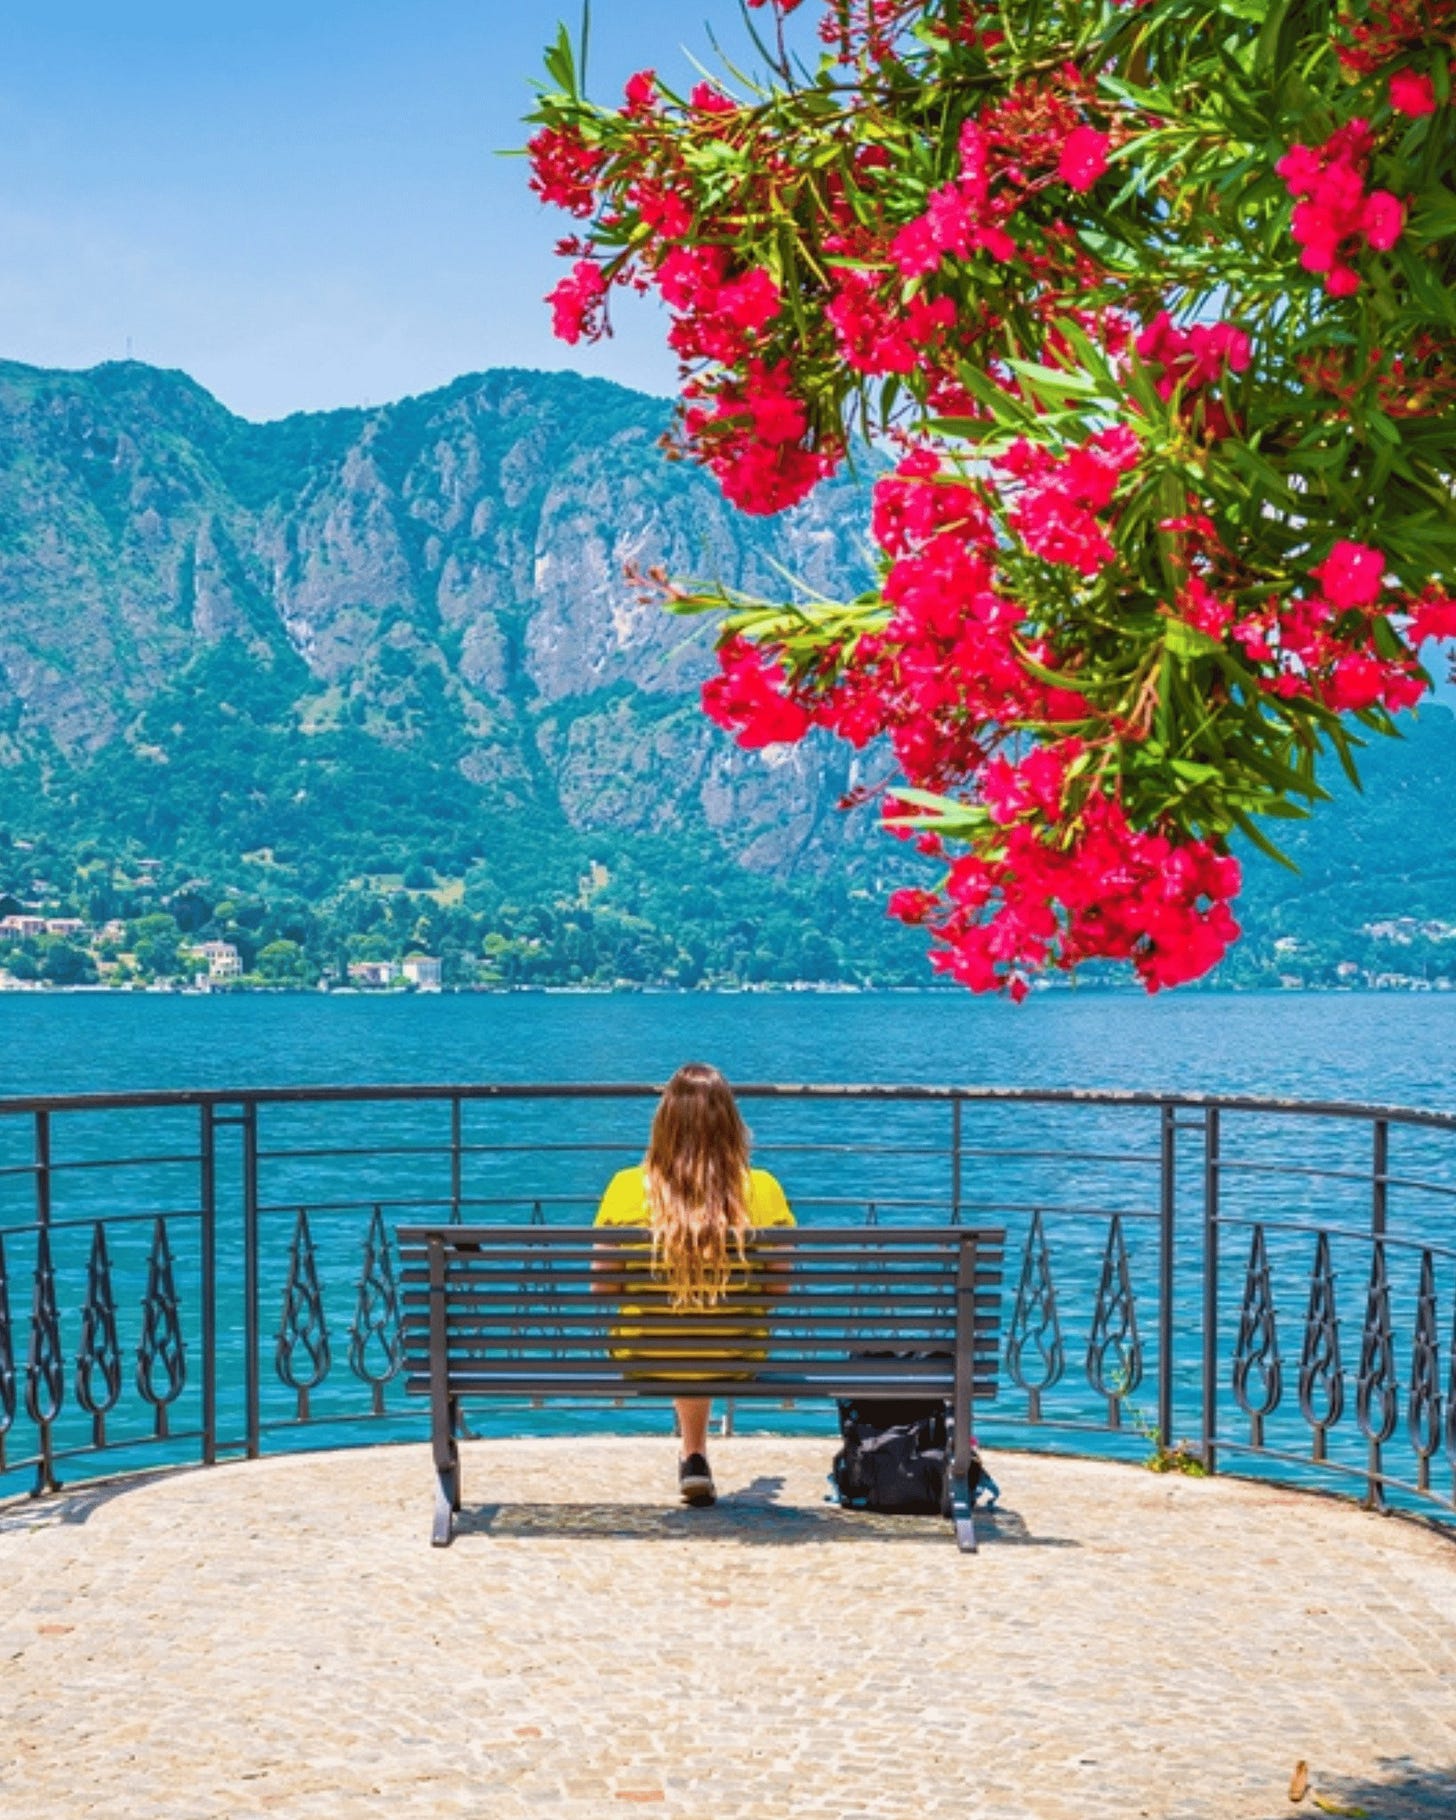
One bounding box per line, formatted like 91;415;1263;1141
597;1061;794;1505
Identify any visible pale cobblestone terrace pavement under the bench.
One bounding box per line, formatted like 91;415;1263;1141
0;1438;1456;1820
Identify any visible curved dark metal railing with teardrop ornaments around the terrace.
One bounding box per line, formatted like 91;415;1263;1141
0;1085;1456;1516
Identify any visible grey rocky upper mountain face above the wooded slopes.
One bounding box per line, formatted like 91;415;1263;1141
0;362;870;872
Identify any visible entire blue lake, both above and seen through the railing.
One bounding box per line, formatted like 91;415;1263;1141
0;990;1456;1514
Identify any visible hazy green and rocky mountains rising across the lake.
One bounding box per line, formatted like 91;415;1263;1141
0;362;1456;981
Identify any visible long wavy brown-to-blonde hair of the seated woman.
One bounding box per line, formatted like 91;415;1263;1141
646;1061;752;1310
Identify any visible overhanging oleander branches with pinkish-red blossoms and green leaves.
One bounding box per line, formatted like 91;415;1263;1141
530;0;1456;996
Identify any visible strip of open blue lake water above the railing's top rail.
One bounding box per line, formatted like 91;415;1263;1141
0;992;1456;1108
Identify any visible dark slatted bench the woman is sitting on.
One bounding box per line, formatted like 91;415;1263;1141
399;1225;1005;1551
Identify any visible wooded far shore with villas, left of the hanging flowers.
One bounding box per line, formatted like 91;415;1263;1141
0;848;888;994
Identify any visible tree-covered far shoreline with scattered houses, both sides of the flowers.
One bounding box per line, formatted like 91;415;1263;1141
0;830;1456;994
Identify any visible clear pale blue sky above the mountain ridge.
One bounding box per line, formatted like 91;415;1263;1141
0;0;811;417
